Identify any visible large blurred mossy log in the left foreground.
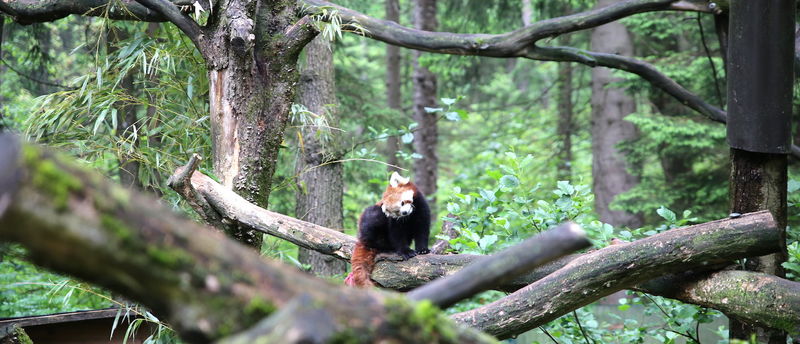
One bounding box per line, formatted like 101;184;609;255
0;136;496;343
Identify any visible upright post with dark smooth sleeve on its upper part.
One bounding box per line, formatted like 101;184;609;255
727;0;796;343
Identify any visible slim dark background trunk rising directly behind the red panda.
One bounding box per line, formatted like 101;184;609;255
413;0;439;204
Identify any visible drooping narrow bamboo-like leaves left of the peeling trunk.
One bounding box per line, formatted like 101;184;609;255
9;19;210;202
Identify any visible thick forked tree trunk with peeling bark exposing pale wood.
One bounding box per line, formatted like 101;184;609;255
201;1;313;249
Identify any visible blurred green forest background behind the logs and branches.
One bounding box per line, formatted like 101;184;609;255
0;0;800;342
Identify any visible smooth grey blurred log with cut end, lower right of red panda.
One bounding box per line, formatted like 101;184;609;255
408;222;591;308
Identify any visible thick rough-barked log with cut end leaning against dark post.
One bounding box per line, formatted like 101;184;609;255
453;212;781;339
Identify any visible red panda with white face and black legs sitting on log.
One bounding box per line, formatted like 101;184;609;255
345;172;431;287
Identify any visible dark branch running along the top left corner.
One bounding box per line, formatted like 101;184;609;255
0;0;166;24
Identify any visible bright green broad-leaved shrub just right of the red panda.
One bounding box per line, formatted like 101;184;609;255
445;152;608;254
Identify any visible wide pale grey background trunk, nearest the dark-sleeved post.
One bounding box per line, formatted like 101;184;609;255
591;0;642;227
